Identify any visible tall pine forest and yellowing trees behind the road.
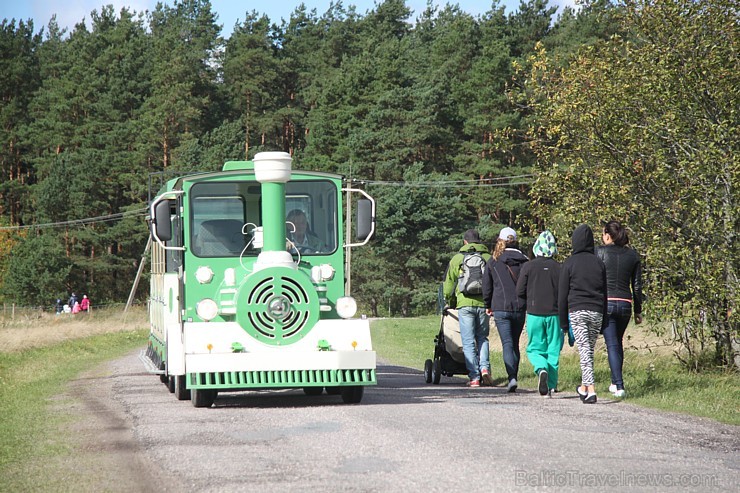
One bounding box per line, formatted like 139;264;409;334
0;0;740;368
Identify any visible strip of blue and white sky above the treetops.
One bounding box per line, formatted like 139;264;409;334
0;0;574;37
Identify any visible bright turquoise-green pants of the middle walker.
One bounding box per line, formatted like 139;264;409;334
527;313;563;390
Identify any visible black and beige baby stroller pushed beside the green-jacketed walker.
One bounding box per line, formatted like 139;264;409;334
424;308;468;384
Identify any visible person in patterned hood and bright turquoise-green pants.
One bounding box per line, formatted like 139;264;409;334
516;231;563;397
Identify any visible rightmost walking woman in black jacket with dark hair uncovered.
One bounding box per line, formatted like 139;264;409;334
596;221;642;398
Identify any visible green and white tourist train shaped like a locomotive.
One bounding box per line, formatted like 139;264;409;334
141;152;376;407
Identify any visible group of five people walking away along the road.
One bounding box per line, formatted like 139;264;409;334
443;221;642;404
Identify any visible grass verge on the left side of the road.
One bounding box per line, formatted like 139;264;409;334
0;330;148;491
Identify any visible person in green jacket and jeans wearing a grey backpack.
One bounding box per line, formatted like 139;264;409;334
442;229;493;387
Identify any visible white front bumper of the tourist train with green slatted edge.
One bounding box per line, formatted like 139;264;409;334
184;320;377;390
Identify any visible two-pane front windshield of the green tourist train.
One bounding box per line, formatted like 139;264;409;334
190;180;338;257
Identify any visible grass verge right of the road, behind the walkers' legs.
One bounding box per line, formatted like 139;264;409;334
370;316;740;425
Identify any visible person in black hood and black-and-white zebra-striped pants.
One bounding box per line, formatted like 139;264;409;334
558;224;607;404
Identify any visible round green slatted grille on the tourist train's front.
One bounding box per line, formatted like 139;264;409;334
236;267;319;346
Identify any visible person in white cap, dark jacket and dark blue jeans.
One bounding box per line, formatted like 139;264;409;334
483;228;529;392
